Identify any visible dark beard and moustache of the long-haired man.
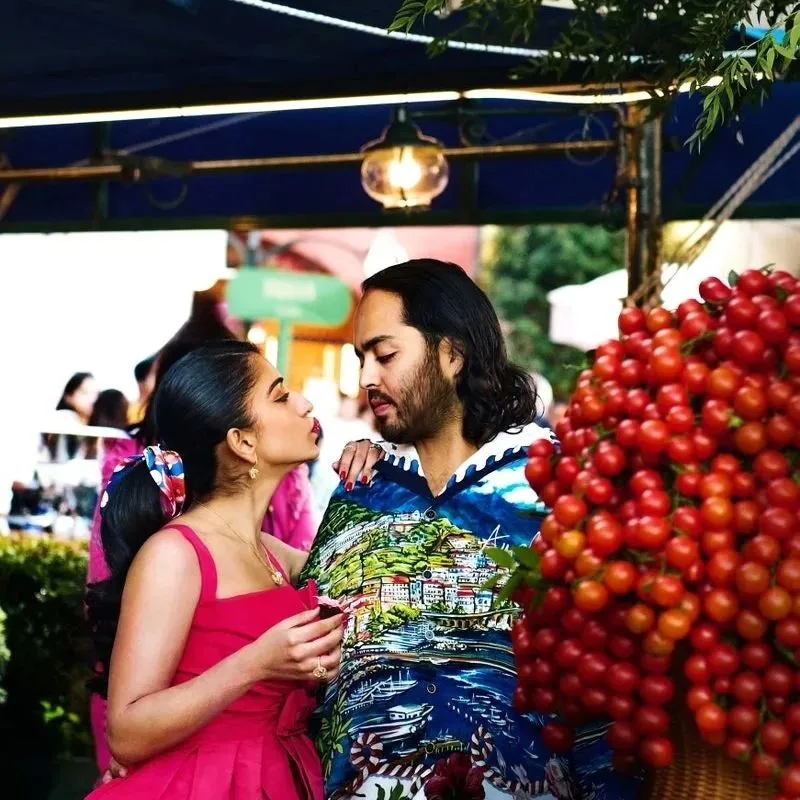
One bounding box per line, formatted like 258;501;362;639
370;350;460;444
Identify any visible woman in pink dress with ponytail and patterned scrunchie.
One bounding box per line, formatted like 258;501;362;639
87;341;342;800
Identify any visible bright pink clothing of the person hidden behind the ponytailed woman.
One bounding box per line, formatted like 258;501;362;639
87;439;317;772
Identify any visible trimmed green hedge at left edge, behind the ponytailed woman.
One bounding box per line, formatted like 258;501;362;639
0;536;92;797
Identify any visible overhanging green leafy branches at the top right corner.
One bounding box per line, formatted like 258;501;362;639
391;0;800;144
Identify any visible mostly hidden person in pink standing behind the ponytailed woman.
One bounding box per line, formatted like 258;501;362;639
87;292;318;773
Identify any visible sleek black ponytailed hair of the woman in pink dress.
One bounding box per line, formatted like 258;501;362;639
86;341;259;694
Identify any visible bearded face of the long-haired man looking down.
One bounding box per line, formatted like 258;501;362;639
355;291;461;444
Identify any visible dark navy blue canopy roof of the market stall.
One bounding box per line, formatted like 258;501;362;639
0;0;800;231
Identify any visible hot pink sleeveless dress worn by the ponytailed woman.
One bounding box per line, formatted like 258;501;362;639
87;525;323;800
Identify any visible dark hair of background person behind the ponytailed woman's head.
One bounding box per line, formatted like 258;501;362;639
134;292;239;445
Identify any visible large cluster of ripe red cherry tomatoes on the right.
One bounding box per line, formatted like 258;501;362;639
513;271;800;798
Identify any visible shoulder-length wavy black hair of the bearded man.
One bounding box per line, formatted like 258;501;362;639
363;258;537;446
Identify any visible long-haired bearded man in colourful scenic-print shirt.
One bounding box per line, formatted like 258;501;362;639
304;260;633;800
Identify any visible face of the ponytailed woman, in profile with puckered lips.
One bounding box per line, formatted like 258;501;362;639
250;358;321;466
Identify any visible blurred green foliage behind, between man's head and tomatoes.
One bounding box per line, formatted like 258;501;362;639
486;225;625;400
